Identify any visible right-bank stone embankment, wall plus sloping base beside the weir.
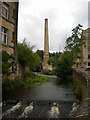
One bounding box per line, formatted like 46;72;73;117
71;69;90;118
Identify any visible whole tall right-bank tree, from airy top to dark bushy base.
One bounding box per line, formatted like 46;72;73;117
56;24;86;81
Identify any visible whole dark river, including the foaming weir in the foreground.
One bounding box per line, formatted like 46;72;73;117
2;76;77;118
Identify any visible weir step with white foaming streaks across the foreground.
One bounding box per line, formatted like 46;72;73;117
2;101;74;119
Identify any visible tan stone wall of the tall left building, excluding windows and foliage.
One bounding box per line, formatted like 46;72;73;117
0;2;18;82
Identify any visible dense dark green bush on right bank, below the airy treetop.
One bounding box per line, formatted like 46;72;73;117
56;52;73;81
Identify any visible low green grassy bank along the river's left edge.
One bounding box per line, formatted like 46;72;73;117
2;71;48;91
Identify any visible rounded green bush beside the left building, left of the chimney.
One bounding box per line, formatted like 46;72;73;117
17;42;40;70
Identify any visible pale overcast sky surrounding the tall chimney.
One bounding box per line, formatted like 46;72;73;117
18;0;89;52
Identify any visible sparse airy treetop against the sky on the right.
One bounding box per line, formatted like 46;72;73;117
65;24;86;59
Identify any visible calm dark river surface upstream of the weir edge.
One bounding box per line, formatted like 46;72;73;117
3;77;76;101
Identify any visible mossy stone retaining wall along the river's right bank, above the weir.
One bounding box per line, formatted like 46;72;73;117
73;69;90;99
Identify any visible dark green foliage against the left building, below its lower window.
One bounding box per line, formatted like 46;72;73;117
2;51;12;74
